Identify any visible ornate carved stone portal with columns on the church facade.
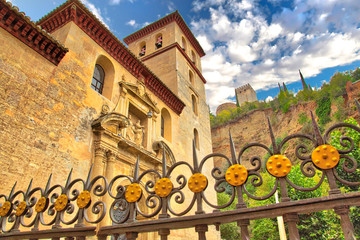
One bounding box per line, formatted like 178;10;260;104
92;78;175;227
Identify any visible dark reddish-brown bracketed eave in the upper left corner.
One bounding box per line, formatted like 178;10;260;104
0;0;68;65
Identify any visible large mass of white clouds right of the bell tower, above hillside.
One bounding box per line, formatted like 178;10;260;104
191;0;360;112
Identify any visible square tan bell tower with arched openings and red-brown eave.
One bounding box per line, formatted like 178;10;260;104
124;11;212;160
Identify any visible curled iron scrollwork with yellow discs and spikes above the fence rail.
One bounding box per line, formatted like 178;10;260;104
0;110;360;234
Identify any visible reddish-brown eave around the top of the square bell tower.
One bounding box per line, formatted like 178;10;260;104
123;11;205;57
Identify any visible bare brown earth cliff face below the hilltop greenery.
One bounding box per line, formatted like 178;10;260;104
211;101;360;167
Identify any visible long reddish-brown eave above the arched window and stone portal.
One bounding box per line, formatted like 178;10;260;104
37;0;185;114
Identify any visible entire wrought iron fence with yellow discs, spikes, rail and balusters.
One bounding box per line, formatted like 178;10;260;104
0;113;360;239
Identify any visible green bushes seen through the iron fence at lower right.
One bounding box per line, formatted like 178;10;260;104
218;117;360;240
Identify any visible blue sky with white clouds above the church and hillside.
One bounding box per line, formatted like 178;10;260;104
7;0;360;112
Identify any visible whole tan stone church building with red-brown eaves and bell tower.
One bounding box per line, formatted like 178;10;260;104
0;0;218;239
